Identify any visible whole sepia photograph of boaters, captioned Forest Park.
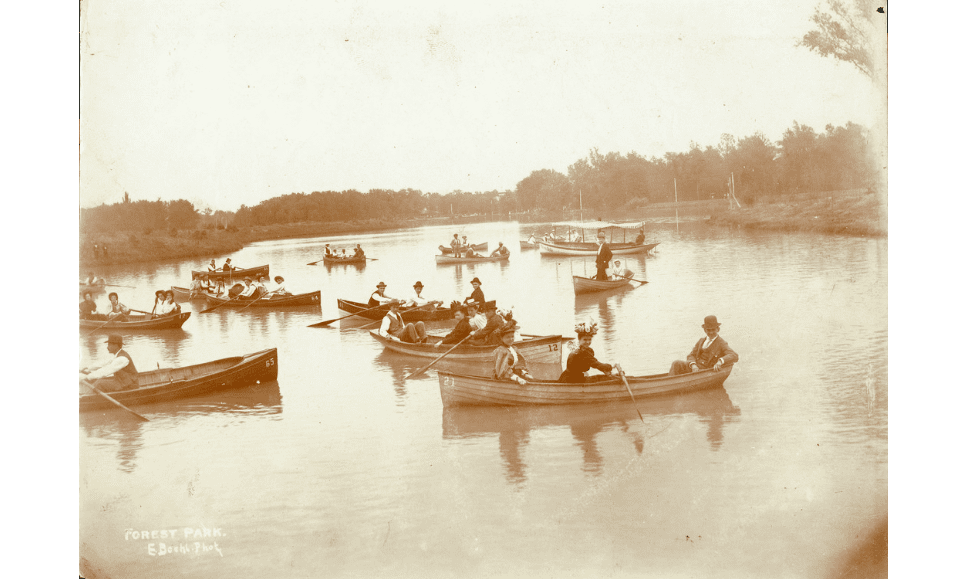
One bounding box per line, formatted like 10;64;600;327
77;0;889;579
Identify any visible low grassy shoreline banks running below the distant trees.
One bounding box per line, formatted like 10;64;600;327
79;192;888;270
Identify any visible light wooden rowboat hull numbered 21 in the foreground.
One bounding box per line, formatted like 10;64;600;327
437;366;732;406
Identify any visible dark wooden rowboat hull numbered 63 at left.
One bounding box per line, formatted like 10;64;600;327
79;348;278;411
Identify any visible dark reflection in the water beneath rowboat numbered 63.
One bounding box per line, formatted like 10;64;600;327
79;380;282;473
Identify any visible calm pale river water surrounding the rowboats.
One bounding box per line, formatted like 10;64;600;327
79;222;888;578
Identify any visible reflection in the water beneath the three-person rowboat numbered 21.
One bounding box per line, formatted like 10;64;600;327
443;388;741;486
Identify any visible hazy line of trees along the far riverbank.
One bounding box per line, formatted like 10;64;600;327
81;122;875;231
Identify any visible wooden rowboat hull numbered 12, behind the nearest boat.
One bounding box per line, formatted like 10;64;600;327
369;330;572;364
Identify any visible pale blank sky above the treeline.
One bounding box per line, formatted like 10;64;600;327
79;0;884;211
